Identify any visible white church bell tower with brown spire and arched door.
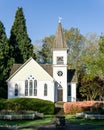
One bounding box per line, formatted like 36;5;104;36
53;21;67;102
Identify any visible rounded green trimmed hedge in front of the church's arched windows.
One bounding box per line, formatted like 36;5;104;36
0;98;55;114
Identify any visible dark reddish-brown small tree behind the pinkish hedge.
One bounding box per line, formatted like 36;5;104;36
79;76;104;100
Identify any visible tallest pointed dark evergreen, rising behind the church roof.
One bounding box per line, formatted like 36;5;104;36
10;8;33;63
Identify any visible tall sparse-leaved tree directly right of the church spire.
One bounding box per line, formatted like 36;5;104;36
64;27;85;69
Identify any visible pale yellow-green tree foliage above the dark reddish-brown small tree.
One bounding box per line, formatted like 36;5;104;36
78;34;99;75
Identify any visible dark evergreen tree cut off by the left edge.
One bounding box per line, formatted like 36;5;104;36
0;21;13;98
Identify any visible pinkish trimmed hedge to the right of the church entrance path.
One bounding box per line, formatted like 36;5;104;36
64;101;104;114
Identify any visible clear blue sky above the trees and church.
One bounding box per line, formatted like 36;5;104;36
0;0;104;43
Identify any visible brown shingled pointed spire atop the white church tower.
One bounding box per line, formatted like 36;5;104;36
53;21;67;49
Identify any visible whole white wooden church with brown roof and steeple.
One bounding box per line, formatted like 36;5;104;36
7;22;77;102
